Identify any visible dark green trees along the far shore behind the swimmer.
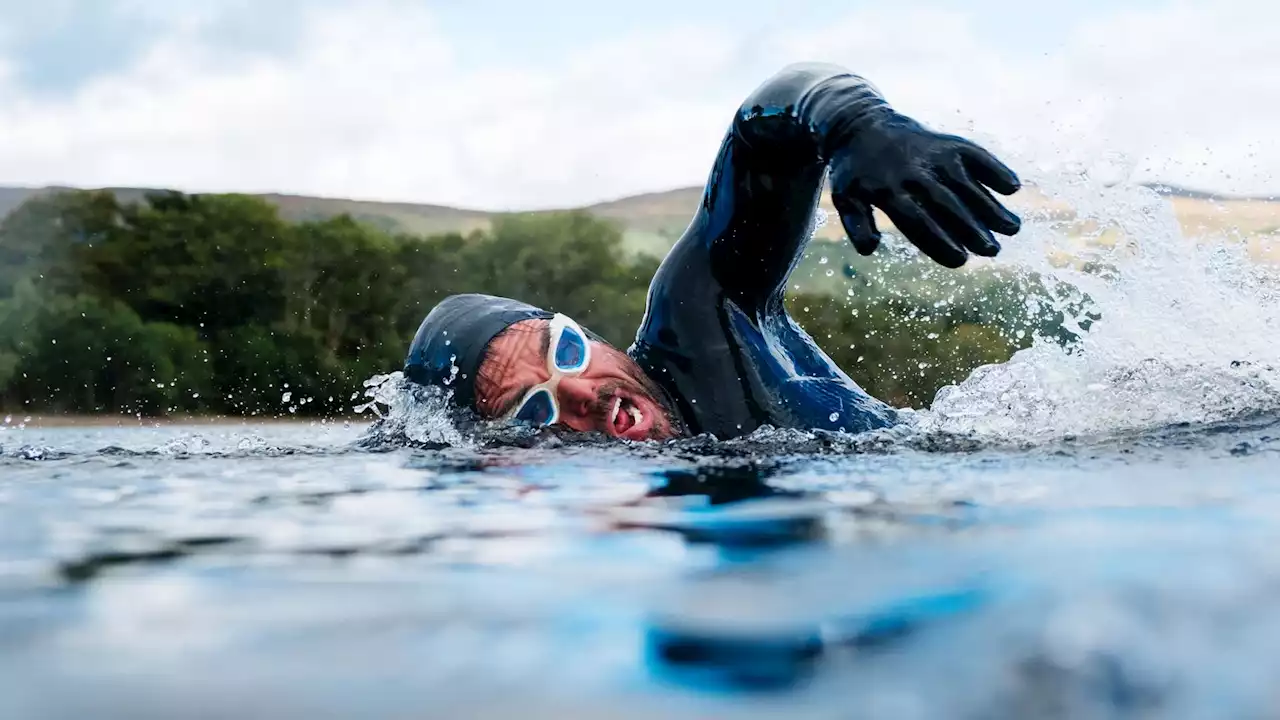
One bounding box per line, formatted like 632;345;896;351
0;191;1053;416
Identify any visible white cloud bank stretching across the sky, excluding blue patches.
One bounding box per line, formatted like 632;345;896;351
0;0;1280;208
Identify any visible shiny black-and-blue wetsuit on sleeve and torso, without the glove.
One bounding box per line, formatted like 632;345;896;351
627;65;895;438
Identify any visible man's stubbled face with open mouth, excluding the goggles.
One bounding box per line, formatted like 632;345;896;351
476;320;677;439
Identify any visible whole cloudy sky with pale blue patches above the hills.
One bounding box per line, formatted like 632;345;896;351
0;0;1280;210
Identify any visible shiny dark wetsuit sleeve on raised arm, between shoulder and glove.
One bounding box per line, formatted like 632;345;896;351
691;64;892;314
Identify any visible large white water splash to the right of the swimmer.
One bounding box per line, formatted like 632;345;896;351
916;173;1280;442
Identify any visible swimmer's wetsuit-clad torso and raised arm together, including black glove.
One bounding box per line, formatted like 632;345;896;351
628;64;1019;437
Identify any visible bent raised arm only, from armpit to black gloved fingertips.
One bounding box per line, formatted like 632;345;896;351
650;64;1019;314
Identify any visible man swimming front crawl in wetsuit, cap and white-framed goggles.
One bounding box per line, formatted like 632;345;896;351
404;64;1020;439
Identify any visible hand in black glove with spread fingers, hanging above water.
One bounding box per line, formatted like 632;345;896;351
829;109;1021;268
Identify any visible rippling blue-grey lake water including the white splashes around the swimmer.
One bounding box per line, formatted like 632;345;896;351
0;177;1280;720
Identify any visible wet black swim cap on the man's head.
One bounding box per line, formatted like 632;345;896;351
404;295;552;407
